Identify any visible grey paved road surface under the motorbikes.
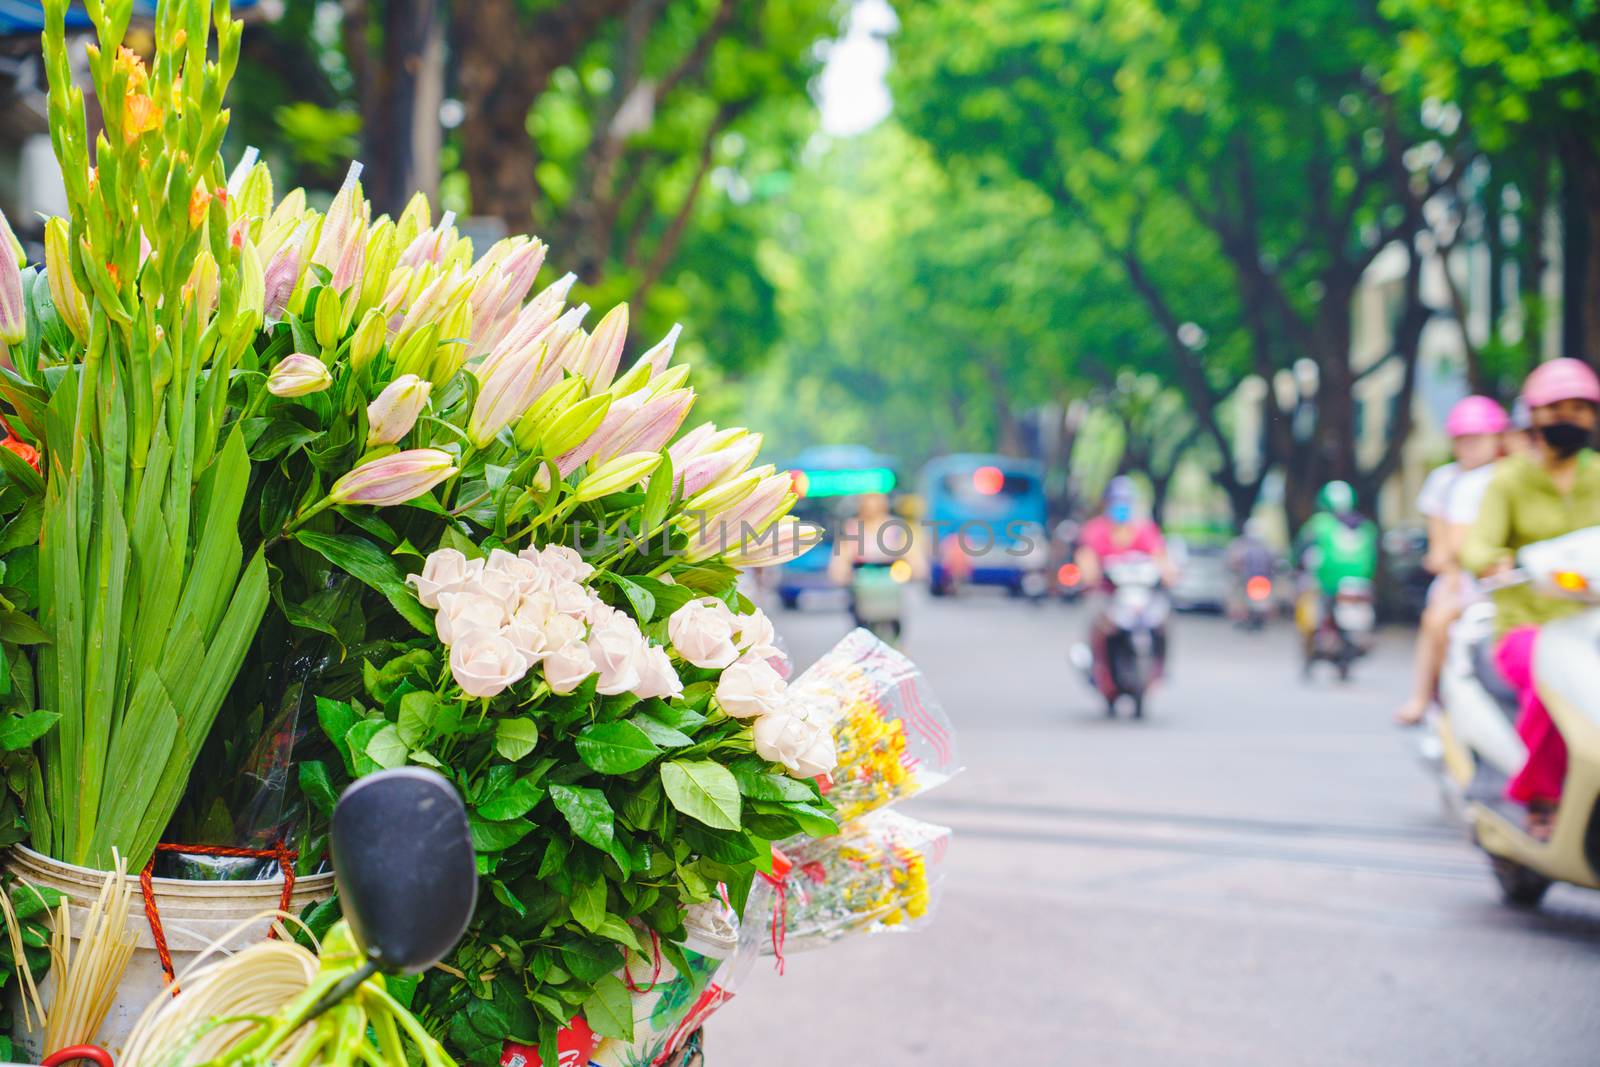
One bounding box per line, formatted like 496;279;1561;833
709;598;1600;1067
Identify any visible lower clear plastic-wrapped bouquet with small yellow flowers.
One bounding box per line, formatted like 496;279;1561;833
747;811;950;953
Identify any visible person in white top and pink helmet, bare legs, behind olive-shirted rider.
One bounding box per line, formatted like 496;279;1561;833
1395;397;1510;726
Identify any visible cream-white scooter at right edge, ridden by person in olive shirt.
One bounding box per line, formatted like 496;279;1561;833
1421;528;1600;909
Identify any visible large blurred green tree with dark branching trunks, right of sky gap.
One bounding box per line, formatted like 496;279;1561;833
894;0;1459;517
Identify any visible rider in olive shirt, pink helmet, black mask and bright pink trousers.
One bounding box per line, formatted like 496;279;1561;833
1461;358;1600;837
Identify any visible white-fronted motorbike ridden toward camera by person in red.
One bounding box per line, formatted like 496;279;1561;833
1075;555;1171;718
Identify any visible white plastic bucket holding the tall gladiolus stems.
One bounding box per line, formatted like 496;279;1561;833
5;845;333;1064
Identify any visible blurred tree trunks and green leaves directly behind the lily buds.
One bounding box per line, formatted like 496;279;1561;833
235;0;843;382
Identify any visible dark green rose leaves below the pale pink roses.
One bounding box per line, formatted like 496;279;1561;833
301;556;835;1062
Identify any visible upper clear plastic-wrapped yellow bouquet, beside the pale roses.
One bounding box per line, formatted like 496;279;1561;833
790;629;962;824
